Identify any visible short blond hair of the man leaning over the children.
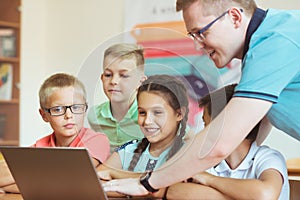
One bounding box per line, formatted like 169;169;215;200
176;0;257;16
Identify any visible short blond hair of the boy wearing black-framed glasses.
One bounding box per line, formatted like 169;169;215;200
39;73;86;108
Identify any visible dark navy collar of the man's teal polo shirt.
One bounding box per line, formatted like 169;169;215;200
243;8;267;59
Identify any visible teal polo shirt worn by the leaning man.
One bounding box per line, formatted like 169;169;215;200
234;9;300;140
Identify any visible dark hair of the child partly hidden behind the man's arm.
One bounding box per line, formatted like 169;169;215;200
199;84;260;141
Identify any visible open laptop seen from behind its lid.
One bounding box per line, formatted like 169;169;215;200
0;147;108;200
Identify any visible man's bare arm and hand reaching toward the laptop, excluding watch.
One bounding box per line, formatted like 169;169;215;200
104;97;272;195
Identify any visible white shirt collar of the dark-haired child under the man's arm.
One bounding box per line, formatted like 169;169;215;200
215;142;259;173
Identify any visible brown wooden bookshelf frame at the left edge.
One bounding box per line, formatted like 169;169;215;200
0;0;21;146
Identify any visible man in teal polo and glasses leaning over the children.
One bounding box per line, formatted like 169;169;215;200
104;0;300;198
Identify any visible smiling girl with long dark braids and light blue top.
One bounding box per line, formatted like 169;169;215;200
100;75;188;178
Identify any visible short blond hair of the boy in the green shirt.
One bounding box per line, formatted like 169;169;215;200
104;43;145;69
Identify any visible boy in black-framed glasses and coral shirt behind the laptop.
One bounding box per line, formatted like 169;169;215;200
0;73;110;192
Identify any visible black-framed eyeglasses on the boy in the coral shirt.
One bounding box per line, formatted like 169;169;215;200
44;104;88;116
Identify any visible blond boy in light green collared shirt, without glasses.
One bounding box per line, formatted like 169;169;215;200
88;43;146;152
